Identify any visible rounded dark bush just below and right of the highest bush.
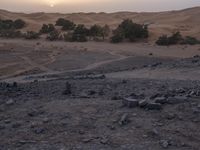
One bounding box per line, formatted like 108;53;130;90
72;24;89;42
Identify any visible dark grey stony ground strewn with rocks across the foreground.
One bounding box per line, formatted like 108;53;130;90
0;53;200;150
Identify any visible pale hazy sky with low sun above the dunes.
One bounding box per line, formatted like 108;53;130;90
0;0;200;12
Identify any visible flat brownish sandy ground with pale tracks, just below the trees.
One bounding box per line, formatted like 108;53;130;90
0;40;200;79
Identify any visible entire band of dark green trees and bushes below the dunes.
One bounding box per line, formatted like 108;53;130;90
0;18;200;46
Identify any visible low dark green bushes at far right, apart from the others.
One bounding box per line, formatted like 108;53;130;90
156;32;200;46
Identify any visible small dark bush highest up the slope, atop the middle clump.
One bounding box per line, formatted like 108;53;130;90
56;18;76;31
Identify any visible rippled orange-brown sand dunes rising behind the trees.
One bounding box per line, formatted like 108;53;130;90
0;7;200;40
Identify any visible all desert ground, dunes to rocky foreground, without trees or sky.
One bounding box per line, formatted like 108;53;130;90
0;4;200;150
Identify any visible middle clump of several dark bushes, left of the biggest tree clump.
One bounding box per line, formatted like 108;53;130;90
40;18;110;42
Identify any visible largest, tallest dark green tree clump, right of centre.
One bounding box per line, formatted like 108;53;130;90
111;19;149;43
